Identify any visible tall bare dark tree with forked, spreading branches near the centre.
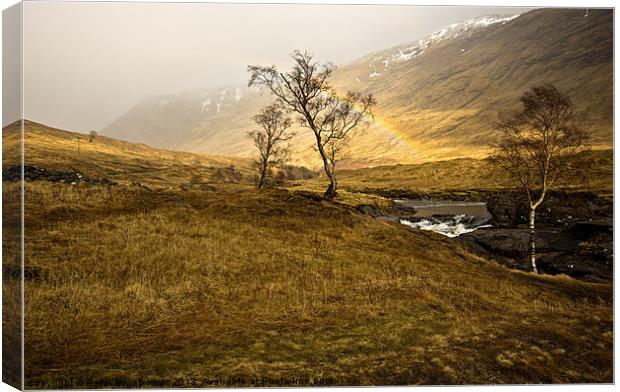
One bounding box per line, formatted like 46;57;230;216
248;51;376;198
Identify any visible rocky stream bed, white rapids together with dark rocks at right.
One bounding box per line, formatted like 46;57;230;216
358;192;613;281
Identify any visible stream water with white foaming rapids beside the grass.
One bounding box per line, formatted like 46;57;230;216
394;199;491;237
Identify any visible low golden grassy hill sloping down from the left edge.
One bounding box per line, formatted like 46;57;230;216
2;120;251;185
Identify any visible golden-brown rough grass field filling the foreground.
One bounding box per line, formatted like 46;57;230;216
3;122;613;389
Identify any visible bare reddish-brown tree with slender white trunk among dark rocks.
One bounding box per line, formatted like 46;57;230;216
491;84;589;272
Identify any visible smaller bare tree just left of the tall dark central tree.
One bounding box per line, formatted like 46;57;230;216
248;103;295;188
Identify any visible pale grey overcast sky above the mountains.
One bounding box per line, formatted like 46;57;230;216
14;2;526;131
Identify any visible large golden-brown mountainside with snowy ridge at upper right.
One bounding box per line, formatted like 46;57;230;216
335;6;613;158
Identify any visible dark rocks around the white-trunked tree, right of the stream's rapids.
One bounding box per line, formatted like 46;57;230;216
458;193;613;281
